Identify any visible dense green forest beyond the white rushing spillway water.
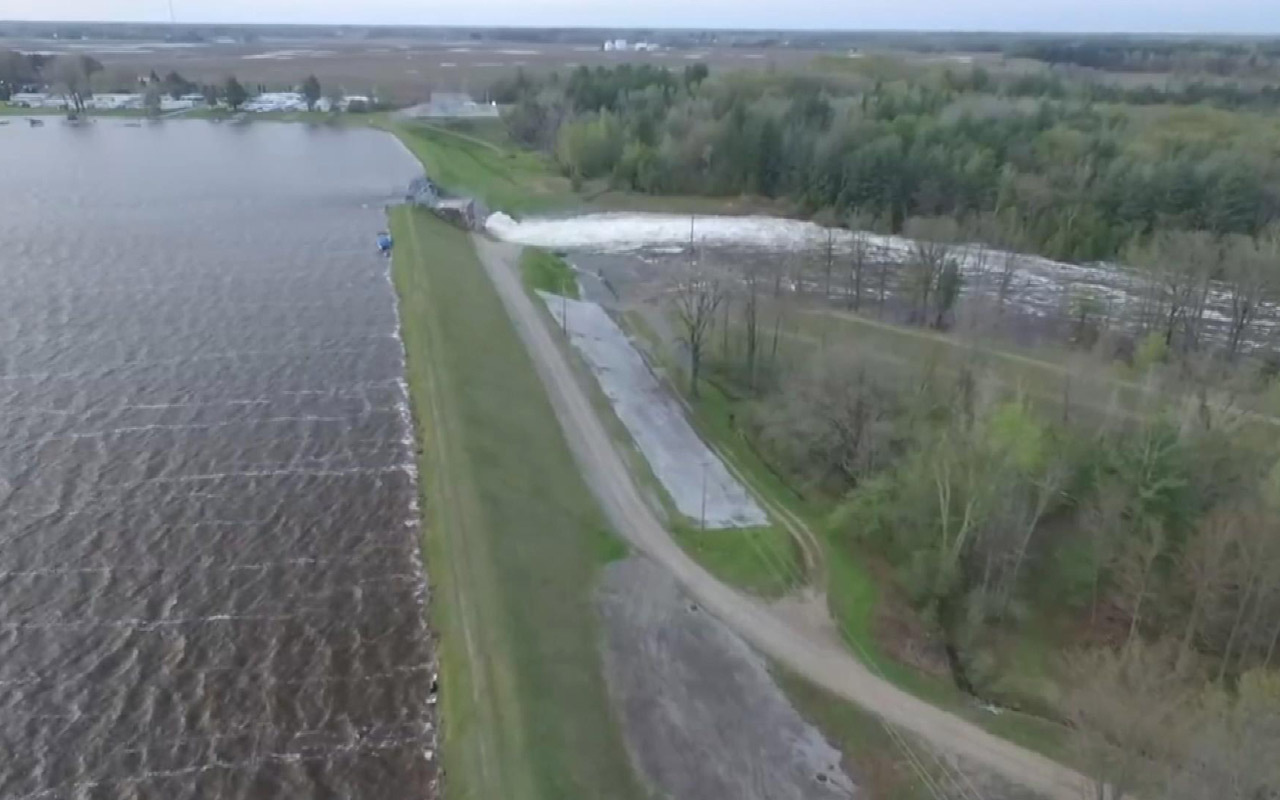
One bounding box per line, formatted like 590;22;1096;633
500;67;1280;260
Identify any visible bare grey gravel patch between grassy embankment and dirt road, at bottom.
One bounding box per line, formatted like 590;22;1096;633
596;556;864;800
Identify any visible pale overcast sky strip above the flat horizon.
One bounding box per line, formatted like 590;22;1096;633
0;0;1280;33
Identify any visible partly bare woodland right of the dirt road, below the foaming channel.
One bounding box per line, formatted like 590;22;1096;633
686;247;1280;797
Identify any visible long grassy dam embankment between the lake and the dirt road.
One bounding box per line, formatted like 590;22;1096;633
392;209;641;800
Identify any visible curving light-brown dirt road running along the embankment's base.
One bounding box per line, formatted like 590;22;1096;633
474;236;1091;800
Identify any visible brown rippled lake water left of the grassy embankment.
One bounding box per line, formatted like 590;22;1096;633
0;120;435;800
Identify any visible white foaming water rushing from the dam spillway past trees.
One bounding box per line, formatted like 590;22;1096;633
486;214;1280;347
